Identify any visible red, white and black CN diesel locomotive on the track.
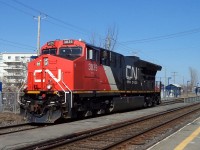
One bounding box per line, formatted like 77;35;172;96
19;40;162;123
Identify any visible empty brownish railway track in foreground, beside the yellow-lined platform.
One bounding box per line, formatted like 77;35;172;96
16;104;200;150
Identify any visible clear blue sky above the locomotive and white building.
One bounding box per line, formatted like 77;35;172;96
0;0;200;84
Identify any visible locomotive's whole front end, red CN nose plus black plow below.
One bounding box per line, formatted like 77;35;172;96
20;54;73;123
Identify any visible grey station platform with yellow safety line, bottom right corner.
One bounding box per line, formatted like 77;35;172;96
148;117;200;150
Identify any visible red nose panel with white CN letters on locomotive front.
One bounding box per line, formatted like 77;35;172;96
27;55;72;91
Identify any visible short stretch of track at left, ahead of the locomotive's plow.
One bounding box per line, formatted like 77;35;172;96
0;123;38;136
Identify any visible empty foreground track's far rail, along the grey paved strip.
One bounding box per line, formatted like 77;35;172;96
16;104;200;150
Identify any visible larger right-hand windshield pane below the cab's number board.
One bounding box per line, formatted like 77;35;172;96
59;47;82;60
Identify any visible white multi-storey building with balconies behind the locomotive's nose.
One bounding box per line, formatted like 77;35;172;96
0;53;37;88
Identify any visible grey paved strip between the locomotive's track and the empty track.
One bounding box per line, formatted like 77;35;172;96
0;99;199;149
